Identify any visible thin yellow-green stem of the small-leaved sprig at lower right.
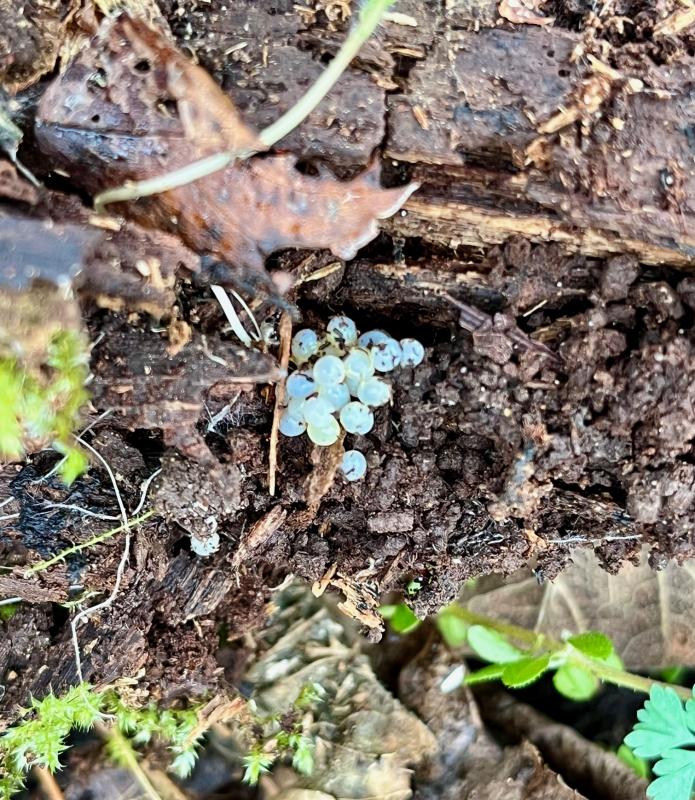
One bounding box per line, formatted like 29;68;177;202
447;605;693;700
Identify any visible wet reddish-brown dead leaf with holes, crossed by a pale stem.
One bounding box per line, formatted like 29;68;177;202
37;15;416;294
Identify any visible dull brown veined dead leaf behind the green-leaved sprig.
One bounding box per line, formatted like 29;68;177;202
466;550;695;670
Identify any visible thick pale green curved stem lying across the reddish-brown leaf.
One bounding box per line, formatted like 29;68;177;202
94;0;393;213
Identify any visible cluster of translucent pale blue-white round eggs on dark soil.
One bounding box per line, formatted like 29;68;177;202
280;316;425;481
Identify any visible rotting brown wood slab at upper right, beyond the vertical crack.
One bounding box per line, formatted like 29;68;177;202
386;28;695;267
